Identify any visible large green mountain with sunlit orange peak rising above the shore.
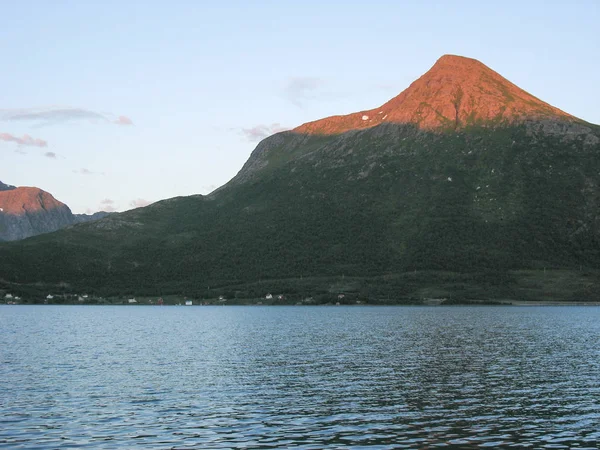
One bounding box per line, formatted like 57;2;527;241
0;56;600;302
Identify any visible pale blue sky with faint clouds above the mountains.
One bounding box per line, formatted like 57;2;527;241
0;0;600;213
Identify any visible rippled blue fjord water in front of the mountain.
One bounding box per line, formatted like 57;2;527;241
0;306;600;449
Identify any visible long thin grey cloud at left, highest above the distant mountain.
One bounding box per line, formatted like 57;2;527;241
0;107;133;126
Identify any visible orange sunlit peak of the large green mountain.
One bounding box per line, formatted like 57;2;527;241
295;55;579;134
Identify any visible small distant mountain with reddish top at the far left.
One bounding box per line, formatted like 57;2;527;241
0;182;106;241
